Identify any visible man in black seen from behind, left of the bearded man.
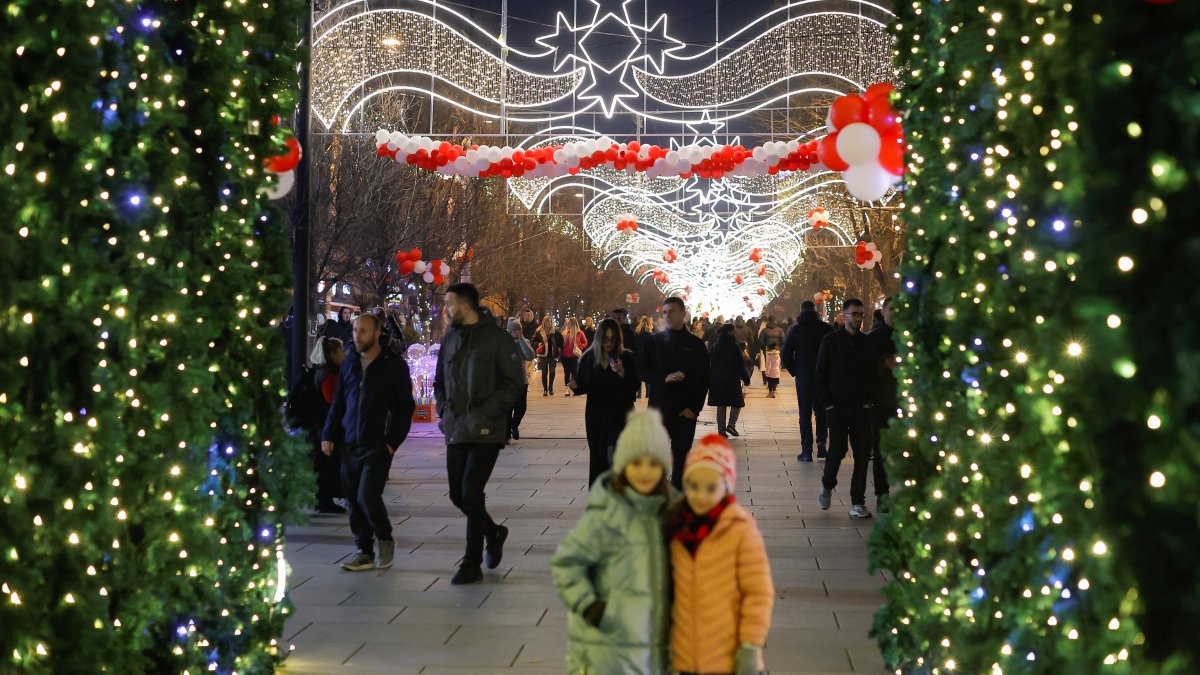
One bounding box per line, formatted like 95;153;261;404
780;300;833;461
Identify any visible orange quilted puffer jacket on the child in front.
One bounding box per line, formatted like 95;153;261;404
671;502;775;673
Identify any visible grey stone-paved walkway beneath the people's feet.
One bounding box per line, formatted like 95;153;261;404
276;372;883;675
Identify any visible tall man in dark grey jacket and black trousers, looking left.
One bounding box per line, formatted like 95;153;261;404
433;283;524;585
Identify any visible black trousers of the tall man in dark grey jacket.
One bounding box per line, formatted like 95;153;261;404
446;443;504;567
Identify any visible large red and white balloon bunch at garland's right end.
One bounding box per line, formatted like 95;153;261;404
817;82;905;202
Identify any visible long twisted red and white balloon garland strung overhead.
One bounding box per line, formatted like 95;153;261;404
376;129;818;179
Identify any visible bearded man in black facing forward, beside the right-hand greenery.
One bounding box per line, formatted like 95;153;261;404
816;298;880;518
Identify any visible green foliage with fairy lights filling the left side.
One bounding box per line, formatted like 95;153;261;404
0;0;310;674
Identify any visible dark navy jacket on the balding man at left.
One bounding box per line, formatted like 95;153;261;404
320;350;416;448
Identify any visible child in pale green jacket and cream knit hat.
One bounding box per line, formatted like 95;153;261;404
550;410;678;675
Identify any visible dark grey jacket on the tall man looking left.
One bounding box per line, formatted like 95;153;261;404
433;309;526;446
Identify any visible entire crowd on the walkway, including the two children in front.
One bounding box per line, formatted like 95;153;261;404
289;283;896;674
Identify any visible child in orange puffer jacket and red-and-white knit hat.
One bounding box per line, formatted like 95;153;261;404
668;434;775;675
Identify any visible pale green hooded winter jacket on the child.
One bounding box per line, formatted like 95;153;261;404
550;472;671;675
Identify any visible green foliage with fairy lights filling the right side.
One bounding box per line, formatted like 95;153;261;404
871;0;1200;673
